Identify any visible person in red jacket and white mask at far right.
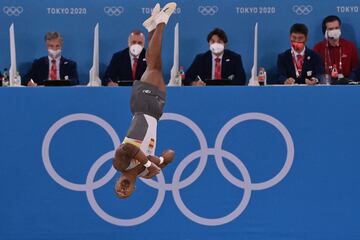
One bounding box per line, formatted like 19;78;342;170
314;15;358;78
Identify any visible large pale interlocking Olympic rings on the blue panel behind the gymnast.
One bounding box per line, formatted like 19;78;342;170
42;113;295;226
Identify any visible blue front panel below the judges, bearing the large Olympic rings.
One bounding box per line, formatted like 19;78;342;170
0;87;360;240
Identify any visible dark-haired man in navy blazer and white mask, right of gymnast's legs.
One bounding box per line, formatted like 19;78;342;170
184;28;246;86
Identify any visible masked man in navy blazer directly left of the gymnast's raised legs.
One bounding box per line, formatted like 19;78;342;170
102;30;146;86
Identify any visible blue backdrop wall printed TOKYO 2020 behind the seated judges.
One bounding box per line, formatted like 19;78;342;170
0;0;360;84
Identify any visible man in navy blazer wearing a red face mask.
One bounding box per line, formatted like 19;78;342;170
277;23;324;85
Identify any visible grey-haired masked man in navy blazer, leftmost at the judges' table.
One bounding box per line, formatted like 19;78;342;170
22;32;79;86
